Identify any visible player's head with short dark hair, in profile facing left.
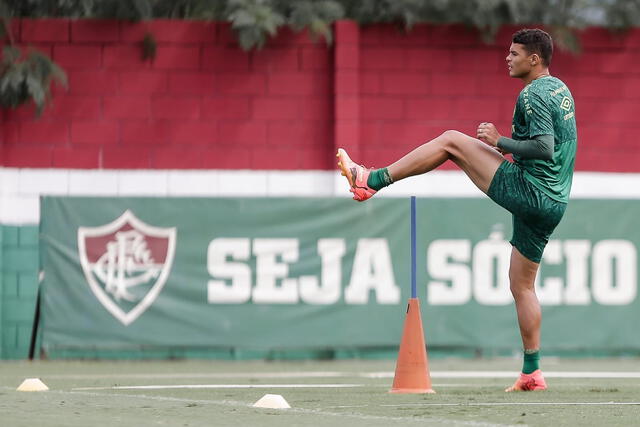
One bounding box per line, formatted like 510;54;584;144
506;28;553;78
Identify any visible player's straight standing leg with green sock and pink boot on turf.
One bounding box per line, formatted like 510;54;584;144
505;247;547;391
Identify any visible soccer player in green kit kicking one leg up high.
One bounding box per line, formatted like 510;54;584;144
337;29;577;391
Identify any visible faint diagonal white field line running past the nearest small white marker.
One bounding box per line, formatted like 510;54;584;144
0;387;511;427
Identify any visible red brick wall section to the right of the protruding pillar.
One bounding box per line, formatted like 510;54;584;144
352;26;640;172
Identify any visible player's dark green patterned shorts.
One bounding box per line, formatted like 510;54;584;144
487;160;567;263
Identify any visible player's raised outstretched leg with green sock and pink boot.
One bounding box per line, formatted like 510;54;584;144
337;130;504;201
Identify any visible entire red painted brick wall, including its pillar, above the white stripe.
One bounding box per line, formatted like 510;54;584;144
0;20;640;172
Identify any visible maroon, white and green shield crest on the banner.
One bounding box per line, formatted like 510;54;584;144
78;210;176;325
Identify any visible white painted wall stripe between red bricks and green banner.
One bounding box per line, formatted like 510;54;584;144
0;167;640;224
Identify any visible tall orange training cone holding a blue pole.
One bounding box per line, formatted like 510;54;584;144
389;298;435;393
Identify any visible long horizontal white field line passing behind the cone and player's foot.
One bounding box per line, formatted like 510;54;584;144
40;371;640;380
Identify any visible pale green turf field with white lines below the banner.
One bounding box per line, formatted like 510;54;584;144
0;358;640;427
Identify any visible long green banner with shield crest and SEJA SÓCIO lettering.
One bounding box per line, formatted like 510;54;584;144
41;197;640;351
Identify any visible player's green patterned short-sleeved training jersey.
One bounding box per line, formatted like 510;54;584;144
511;76;578;203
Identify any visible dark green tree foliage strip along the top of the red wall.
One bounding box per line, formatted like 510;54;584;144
0;0;640;50
